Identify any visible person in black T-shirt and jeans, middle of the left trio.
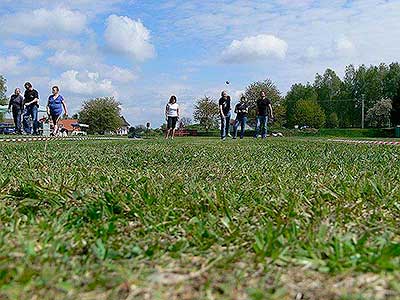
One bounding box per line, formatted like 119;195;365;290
23;82;39;135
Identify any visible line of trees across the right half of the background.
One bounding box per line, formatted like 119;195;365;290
193;63;400;130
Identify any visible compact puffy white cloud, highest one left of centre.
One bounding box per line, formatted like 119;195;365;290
104;15;155;61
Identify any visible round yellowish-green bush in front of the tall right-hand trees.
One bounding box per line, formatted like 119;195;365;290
294;100;325;128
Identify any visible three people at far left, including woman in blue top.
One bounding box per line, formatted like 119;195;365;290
8;82;68;135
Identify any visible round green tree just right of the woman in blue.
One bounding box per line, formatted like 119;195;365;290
79;97;122;134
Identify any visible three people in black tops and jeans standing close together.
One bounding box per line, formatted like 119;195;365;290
218;91;274;140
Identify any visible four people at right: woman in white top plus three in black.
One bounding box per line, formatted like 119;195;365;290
165;91;274;140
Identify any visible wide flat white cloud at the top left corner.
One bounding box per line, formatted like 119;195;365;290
0;7;86;36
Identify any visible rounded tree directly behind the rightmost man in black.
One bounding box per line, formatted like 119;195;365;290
244;79;286;125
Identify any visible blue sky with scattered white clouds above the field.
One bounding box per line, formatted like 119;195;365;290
0;0;400;127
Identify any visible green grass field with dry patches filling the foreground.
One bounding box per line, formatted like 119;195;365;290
0;138;400;299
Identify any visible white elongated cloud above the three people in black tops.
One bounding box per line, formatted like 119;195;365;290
222;34;288;63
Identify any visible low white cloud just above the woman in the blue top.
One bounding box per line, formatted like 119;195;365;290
51;70;118;97
